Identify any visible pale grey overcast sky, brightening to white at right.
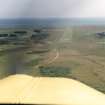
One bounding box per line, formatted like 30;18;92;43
0;0;105;18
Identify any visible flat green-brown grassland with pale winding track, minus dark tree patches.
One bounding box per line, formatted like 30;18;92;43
0;26;105;93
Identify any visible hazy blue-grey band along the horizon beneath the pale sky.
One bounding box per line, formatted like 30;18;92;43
0;18;105;28
